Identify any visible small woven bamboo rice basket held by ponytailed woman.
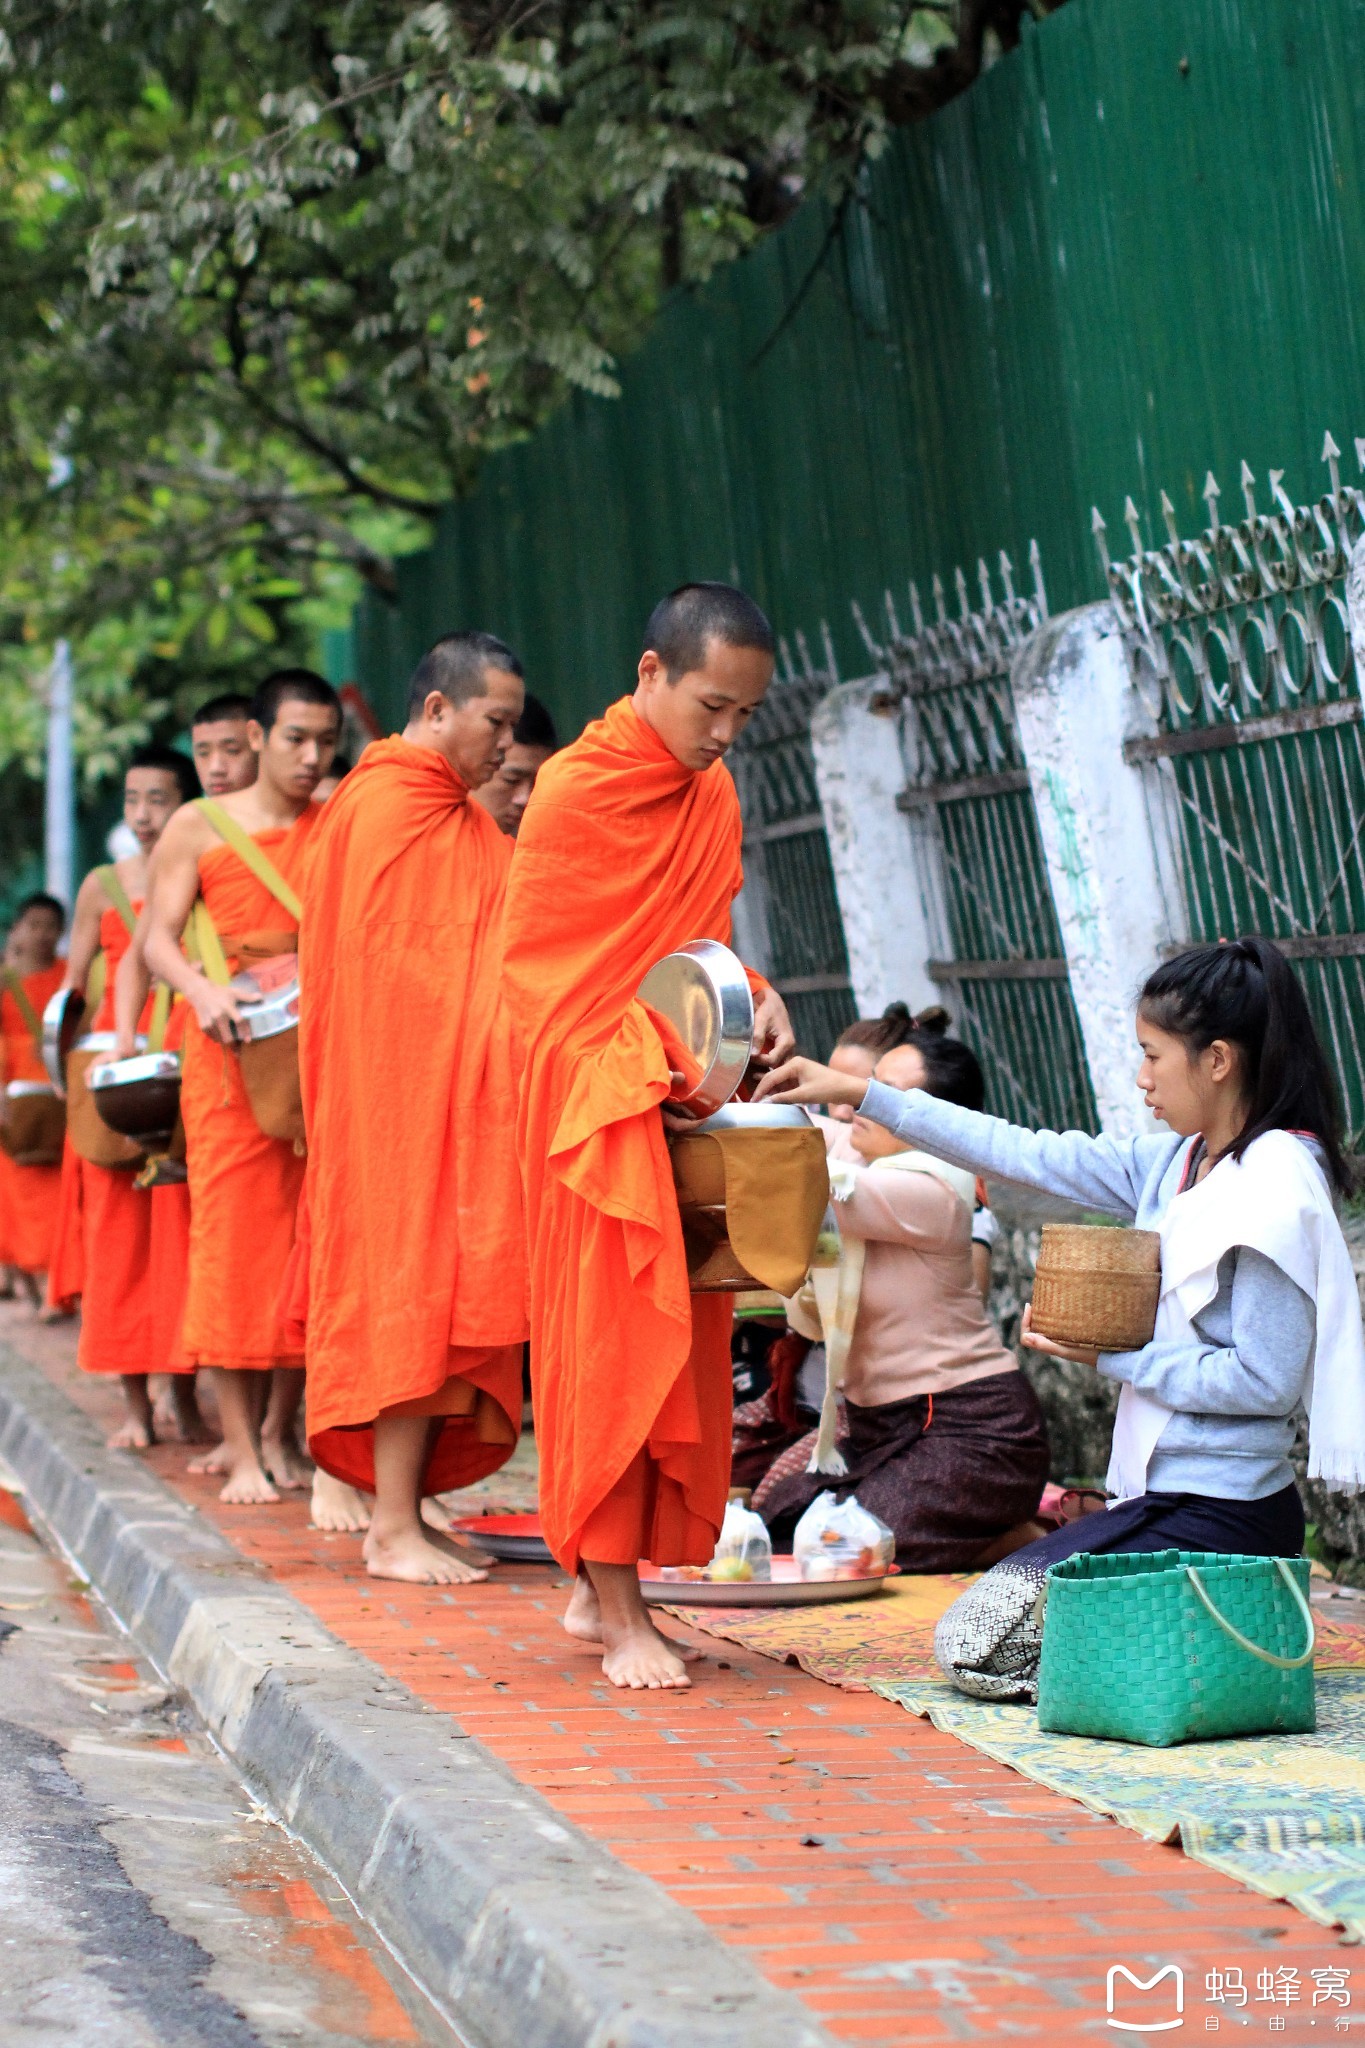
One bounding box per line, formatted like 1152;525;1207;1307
1033;1223;1160;1352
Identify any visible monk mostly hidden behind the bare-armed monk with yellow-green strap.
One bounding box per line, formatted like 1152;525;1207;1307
113;694;259;1441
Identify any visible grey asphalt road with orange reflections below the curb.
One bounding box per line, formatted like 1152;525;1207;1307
0;1473;454;2048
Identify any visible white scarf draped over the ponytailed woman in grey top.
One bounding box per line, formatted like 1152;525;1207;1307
1105;1130;1365;1501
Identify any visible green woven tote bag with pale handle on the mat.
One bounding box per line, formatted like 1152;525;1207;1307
1038;1550;1318;1749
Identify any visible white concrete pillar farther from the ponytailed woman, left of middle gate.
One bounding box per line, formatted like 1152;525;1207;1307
810;676;941;1016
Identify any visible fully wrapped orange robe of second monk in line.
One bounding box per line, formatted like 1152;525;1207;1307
300;739;526;1493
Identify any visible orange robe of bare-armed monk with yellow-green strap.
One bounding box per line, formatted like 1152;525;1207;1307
180;805;323;1372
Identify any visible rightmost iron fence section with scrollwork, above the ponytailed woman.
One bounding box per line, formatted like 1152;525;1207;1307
1095;434;1365;1149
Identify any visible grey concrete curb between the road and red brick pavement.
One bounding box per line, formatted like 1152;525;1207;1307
0;1348;831;2048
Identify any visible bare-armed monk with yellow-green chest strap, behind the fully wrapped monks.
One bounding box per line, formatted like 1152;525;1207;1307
143;670;342;1503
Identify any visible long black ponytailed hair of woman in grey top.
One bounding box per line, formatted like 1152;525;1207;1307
1138;938;1355;1194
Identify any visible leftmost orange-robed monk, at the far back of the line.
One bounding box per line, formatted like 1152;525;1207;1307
0;893;65;1307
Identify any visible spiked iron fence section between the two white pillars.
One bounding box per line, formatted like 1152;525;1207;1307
855;549;1099;1130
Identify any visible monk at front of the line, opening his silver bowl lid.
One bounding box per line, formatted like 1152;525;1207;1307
505;584;792;1688
